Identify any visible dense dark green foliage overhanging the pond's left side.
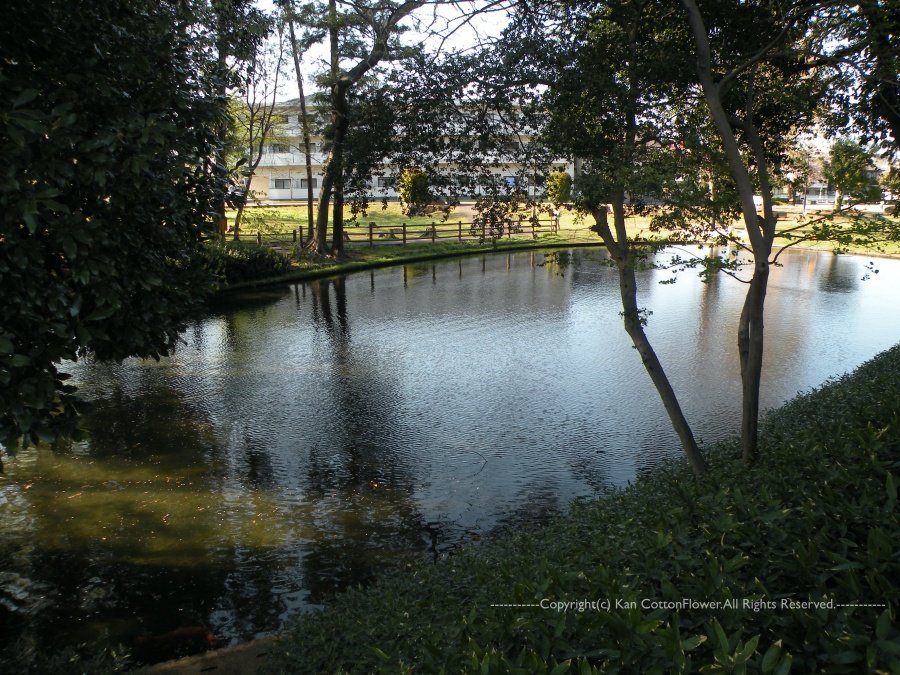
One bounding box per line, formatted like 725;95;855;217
0;0;222;452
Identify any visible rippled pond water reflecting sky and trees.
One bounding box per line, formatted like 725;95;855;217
0;249;900;659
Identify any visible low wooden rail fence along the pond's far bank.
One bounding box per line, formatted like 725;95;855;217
229;218;559;248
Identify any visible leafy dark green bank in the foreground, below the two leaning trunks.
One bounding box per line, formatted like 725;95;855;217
277;346;900;673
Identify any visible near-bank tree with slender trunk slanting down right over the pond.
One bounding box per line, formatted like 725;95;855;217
478;0;706;475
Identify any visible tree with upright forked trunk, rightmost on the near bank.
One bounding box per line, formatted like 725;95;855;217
682;0;856;460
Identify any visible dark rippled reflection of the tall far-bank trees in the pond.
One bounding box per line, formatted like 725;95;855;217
302;277;429;603
